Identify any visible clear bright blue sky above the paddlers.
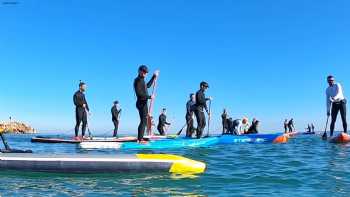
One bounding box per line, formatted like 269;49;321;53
0;0;350;133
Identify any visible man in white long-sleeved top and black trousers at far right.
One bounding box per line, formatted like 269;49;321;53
326;75;348;136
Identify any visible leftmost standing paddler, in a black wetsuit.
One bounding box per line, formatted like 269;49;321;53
73;81;90;140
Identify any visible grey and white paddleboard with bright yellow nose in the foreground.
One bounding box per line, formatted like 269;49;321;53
0;153;206;174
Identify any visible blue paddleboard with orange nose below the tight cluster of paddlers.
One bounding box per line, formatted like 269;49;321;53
219;134;288;144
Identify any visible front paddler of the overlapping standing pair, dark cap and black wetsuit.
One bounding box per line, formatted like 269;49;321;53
195;81;210;139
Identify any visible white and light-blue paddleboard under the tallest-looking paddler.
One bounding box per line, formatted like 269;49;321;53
79;137;219;149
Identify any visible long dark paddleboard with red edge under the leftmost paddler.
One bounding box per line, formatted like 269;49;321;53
31;136;137;144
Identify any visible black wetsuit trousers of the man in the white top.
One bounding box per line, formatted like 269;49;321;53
331;99;348;136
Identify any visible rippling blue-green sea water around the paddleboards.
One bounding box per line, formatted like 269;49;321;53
0;135;350;196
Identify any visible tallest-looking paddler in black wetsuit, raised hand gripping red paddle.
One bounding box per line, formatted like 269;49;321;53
134;65;159;143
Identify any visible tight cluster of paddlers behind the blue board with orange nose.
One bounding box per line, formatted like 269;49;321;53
221;109;260;135
